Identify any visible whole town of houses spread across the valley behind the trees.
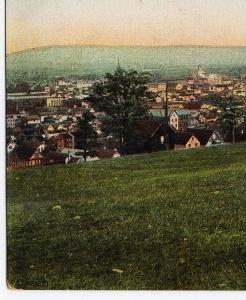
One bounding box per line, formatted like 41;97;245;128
6;67;246;169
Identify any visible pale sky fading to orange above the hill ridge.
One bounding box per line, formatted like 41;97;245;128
6;0;246;53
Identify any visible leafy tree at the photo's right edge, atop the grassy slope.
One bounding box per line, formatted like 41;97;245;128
219;97;245;143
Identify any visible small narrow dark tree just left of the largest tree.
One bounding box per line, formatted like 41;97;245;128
75;110;97;161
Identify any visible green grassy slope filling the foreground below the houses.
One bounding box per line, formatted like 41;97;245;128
8;144;246;289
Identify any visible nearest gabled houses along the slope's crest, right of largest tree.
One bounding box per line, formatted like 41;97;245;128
125;115;225;153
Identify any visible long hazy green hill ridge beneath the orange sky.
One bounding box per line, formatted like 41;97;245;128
6;45;246;80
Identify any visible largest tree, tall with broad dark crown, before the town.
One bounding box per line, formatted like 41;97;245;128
92;66;153;151
